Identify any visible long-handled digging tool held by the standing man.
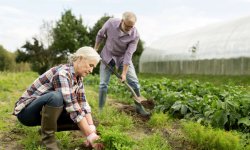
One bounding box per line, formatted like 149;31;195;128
101;60;150;116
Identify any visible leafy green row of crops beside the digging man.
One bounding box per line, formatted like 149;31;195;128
84;76;250;133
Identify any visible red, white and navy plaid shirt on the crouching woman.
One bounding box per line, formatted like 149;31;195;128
14;64;91;122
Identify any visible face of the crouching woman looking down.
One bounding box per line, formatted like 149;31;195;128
75;58;98;77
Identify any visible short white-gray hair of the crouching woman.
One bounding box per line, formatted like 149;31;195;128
68;46;101;63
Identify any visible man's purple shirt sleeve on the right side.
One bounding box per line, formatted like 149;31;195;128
123;36;139;65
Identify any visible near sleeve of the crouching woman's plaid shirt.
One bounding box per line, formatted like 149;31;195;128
53;73;85;123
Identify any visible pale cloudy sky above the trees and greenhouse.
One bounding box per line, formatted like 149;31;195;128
0;0;250;52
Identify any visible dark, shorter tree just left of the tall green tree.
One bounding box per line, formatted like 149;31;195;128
16;38;51;74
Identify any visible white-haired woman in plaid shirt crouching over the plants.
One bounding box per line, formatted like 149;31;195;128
14;47;101;150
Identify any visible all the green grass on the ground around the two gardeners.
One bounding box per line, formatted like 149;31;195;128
0;72;250;150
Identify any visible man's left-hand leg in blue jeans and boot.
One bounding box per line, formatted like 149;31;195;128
99;60;115;112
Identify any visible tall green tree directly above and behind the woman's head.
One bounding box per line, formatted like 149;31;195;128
50;10;90;65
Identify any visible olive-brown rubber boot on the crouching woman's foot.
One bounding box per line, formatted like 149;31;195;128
41;105;63;150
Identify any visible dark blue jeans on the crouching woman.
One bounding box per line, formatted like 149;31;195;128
17;91;74;126
